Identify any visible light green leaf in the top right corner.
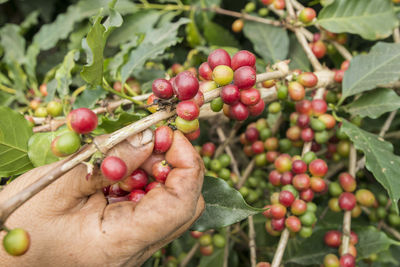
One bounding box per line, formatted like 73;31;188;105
318;0;398;40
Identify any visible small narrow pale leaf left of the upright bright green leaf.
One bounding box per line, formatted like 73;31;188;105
55;50;79;98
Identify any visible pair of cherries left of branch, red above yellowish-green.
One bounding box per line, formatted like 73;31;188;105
51;108;98;157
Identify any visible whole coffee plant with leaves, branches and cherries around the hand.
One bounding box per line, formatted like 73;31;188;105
0;0;400;267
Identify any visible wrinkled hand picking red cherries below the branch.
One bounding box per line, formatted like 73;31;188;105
0;130;204;267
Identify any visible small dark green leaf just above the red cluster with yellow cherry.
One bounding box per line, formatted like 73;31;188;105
204;21;240;47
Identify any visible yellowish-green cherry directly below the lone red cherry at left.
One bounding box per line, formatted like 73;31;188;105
51;131;81;157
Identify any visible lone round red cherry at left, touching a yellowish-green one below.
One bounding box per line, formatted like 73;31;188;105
67;108;98;134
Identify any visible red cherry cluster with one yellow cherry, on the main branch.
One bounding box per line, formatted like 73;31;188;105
199;49;265;121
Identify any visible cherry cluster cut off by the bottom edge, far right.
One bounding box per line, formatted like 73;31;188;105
323;230;358;267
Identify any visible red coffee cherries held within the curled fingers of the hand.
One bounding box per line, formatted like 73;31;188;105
100;125;174;203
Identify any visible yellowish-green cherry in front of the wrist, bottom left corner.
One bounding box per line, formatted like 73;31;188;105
3;228;30;256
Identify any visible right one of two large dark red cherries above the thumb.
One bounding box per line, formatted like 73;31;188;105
172;71;199;101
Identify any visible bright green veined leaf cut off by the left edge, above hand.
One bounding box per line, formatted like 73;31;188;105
0;107;33;177
